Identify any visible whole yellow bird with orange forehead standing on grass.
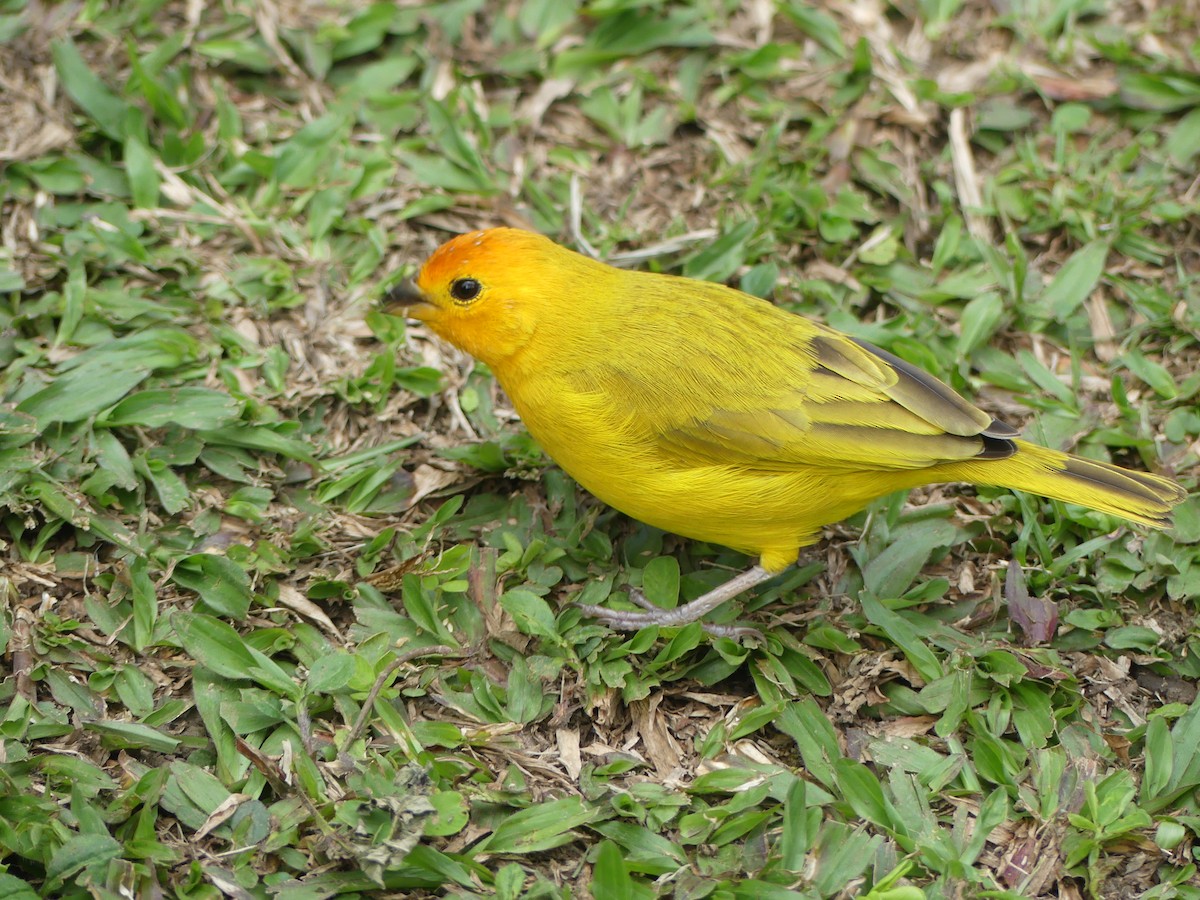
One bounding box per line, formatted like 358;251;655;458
386;228;1186;629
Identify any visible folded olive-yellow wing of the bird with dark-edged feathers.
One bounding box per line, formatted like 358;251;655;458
656;328;1018;470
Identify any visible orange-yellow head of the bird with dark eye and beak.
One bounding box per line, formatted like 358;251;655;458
384;228;580;367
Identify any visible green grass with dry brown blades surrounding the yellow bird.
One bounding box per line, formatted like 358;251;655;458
0;0;1200;900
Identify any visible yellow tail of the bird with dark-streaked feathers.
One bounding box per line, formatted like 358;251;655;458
936;440;1187;528
